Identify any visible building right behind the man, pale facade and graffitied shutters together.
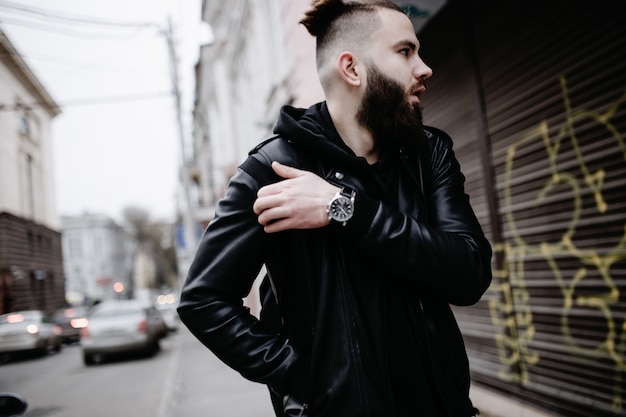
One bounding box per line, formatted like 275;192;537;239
189;0;626;417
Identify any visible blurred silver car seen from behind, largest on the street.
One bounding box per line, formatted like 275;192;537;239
80;300;167;365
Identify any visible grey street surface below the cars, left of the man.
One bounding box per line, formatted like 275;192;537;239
0;327;273;417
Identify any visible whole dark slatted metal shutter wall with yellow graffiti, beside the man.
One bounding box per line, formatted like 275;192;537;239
420;0;626;417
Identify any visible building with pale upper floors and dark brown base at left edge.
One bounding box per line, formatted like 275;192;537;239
0;30;65;313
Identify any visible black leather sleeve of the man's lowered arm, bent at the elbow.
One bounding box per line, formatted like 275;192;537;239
178;162;298;393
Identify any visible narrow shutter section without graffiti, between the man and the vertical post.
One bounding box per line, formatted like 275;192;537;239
418;0;499;406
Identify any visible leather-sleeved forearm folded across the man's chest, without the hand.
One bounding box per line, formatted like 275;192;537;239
359;200;491;305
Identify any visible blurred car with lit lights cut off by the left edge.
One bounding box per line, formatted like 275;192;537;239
0;310;61;354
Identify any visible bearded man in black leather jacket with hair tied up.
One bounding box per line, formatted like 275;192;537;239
179;0;491;417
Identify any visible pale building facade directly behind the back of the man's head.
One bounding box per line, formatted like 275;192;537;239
194;0;321;220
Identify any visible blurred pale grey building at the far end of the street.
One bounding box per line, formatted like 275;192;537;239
62;213;134;304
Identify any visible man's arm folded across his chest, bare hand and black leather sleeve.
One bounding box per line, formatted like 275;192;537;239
254;136;491;305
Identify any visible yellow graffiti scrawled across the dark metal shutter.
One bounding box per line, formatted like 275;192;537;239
489;76;626;412
